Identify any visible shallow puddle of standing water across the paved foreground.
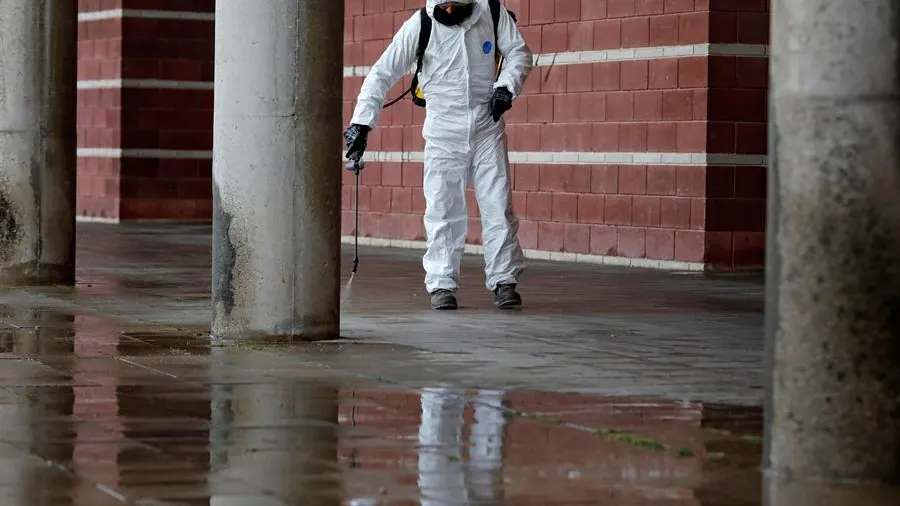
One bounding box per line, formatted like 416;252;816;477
0;368;761;506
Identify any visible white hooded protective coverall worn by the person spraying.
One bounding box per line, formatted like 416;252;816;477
351;0;533;293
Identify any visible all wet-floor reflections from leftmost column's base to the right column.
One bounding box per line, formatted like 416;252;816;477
0;315;761;506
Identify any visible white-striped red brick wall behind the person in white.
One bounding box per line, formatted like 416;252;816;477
344;0;768;267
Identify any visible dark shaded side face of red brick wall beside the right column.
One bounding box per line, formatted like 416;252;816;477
698;0;769;266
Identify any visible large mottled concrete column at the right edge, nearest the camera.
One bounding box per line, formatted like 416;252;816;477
765;0;900;506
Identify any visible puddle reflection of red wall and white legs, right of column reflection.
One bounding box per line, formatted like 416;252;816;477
342;388;761;506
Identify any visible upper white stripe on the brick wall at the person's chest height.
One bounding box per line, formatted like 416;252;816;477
344;44;769;77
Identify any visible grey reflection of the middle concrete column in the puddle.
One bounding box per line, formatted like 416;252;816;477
209;348;342;506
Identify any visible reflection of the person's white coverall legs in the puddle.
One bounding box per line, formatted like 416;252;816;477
419;388;506;506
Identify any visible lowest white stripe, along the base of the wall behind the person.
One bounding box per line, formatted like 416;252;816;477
341;235;705;272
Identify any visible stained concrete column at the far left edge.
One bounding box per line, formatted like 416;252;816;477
0;0;78;285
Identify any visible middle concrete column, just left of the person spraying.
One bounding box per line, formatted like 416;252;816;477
212;0;344;340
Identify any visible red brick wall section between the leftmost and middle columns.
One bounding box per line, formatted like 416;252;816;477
77;0;215;220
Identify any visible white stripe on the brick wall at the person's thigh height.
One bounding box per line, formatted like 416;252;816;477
363;151;766;166
